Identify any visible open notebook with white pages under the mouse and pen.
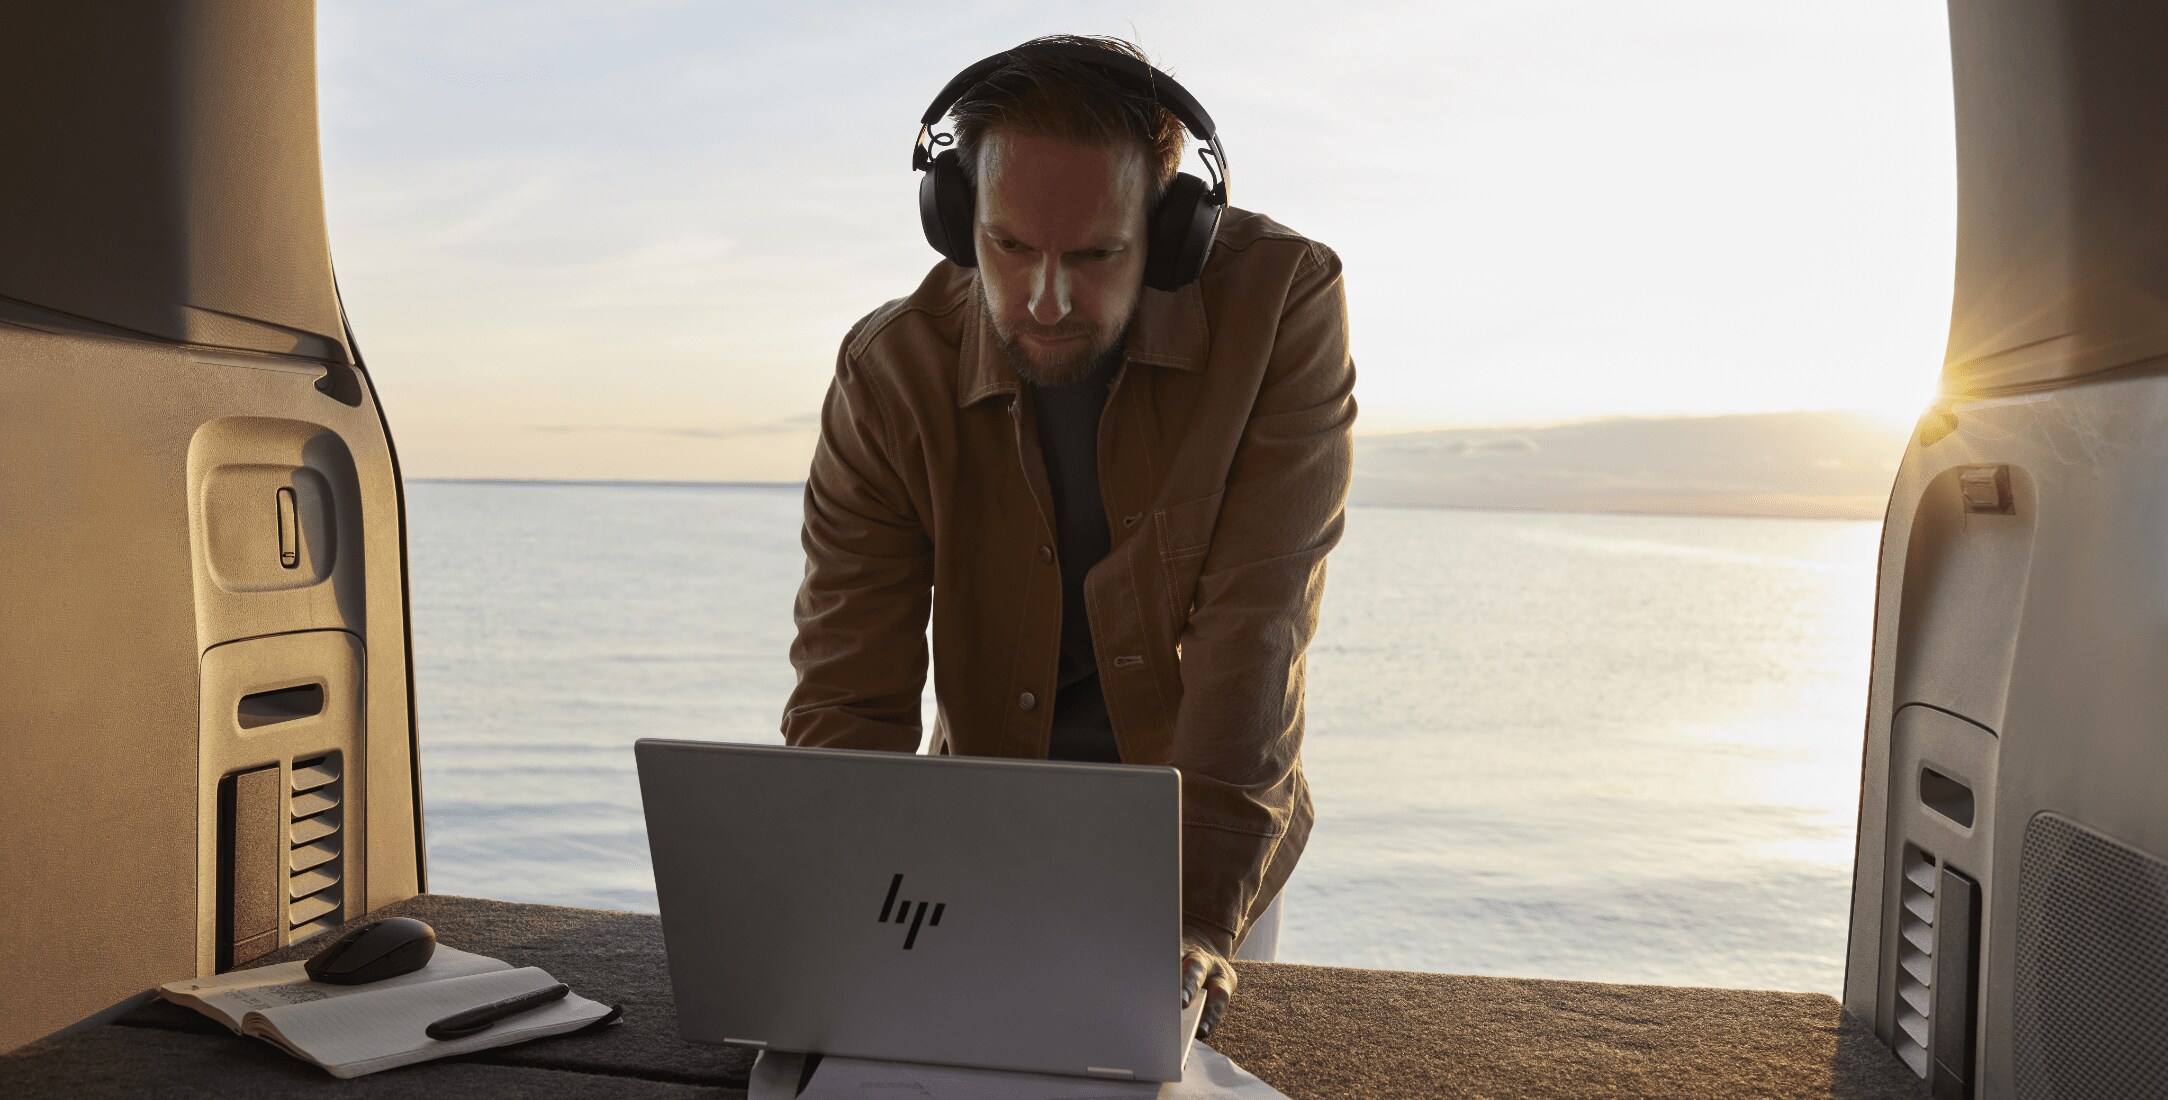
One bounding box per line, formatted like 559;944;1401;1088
158;944;609;1076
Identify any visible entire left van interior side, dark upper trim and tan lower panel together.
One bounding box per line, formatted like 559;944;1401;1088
0;2;421;1050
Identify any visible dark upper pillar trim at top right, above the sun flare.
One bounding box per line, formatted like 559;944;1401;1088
1943;0;2168;395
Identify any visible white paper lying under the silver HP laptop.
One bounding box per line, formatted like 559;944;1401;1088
767;1044;1286;1100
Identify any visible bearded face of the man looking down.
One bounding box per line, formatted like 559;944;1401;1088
973;130;1149;386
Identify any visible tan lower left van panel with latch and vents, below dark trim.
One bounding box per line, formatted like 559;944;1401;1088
0;323;421;1048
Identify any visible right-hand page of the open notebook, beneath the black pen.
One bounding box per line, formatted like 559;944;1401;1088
243;965;609;1076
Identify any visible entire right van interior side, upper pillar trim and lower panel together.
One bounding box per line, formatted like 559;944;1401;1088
1845;0;2168;1096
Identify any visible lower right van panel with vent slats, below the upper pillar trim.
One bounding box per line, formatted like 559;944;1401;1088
1845;384;2168;1096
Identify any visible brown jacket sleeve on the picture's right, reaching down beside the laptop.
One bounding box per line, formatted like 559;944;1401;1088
1175;243;1355;955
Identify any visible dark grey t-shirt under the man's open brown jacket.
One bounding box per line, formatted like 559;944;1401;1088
1032;369;1121;764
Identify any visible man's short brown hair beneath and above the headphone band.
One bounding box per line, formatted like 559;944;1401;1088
950;35;1182;206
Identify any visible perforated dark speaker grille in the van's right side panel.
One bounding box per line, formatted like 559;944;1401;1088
2012;814;2168;1100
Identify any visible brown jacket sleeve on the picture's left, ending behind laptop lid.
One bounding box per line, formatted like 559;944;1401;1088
783;336;932;753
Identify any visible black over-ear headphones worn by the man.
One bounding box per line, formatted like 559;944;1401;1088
911;41;1227;291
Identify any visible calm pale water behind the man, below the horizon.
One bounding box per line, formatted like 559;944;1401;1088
408;482;1880;994
